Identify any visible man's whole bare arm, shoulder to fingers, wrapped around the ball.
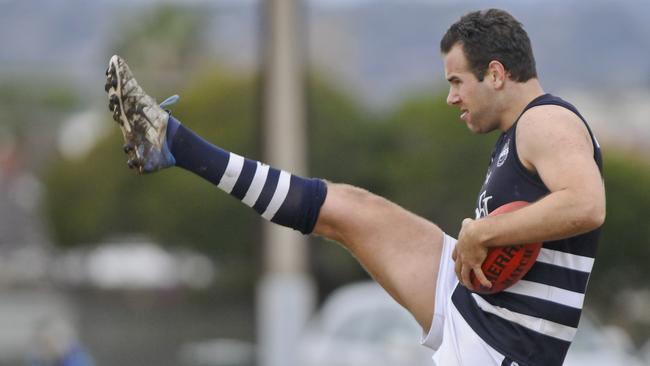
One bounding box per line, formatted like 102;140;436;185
455;106;605;284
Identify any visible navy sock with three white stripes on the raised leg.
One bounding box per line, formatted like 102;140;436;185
167;116;327;234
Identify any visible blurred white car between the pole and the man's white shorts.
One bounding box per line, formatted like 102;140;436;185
298;282;433;366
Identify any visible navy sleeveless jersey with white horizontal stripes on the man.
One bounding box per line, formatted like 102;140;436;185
452;94;602;366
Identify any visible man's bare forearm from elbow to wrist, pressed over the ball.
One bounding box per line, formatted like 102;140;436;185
474;189;605;247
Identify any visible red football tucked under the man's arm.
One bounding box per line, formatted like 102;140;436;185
471;201;542;294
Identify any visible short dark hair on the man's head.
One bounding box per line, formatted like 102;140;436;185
440;9;537;82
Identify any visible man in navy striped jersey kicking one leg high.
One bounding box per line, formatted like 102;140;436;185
105;9;605;366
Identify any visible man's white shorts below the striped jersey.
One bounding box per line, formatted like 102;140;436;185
421;234;517;366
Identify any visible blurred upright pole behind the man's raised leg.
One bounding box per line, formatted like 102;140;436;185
257;0;316;366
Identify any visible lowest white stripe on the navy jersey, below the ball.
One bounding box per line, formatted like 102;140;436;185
472;294;578;342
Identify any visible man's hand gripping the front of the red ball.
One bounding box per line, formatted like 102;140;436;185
451;219;492;289
